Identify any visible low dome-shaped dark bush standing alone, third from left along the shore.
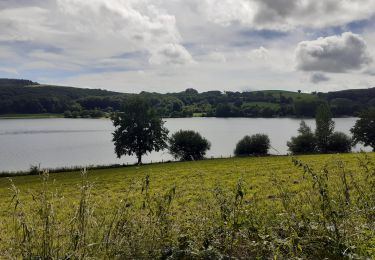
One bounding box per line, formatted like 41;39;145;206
234;134;270;156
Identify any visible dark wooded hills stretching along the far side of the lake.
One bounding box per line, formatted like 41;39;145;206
0;79;375;117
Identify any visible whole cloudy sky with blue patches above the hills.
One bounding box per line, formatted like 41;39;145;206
0;0;375;93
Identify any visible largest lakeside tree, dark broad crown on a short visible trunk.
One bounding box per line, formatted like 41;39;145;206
112;98;168;164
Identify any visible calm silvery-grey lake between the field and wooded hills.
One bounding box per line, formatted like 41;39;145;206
0;118;370;171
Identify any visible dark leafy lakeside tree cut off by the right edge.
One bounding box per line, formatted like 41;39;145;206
350;108;375;151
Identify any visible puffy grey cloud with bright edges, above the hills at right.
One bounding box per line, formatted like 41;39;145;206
296;32;372;73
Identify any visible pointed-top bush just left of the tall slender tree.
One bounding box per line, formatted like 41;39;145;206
287;120;317;154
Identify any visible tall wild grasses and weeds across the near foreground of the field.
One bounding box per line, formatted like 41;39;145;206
0;154;375;259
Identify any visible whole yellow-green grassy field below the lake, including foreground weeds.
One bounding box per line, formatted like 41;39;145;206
0;153;375;259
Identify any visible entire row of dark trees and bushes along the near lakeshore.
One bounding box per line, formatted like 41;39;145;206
112;97;375;164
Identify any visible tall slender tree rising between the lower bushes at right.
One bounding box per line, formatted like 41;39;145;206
315;104;335;153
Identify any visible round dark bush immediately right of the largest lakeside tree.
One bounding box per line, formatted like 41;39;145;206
169;130;211;161
